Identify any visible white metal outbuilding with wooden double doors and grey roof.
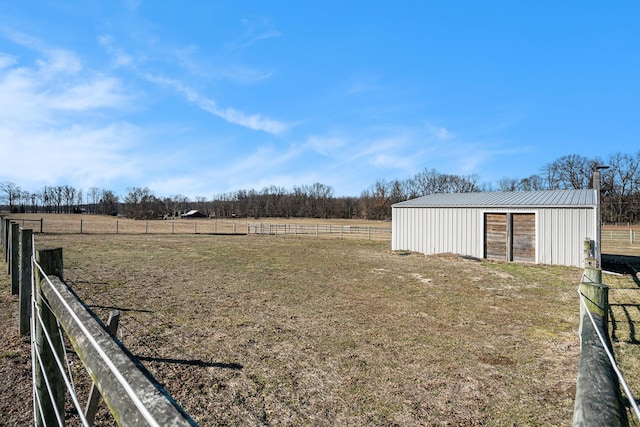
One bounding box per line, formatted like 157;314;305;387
391;190;599;267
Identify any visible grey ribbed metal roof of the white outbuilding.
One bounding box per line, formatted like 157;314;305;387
393;190;597;208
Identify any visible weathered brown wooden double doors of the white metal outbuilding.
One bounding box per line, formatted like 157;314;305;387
484;213;536;262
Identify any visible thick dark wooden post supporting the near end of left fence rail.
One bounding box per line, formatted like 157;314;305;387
33;248;65;426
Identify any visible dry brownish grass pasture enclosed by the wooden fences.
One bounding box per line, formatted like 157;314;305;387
0;216;640;426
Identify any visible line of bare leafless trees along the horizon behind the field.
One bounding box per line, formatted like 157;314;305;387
0;151;640;223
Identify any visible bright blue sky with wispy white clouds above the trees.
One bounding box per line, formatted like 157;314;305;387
0;0;640;198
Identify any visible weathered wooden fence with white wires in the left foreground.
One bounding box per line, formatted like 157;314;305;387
0;221;197;426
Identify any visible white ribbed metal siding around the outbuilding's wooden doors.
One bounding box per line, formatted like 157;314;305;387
391;206;596;267
